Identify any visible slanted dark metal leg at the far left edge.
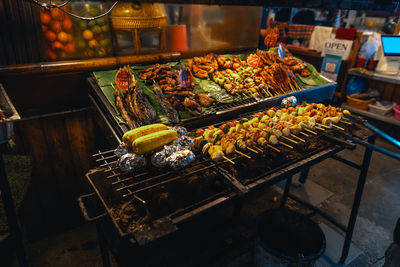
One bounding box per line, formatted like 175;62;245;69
0;148;29;266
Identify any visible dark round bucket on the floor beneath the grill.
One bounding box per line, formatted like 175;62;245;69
254;208;326;267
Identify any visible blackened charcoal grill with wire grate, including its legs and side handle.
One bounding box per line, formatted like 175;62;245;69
79;97;374;264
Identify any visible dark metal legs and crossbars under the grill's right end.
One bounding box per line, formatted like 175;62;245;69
281;136;376;264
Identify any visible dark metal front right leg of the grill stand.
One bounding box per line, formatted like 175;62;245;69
339;136;375;264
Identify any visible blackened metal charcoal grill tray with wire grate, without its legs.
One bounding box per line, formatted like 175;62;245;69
82;104;368;245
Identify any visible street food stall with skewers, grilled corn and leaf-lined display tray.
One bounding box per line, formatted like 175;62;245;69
0;1;398;266
